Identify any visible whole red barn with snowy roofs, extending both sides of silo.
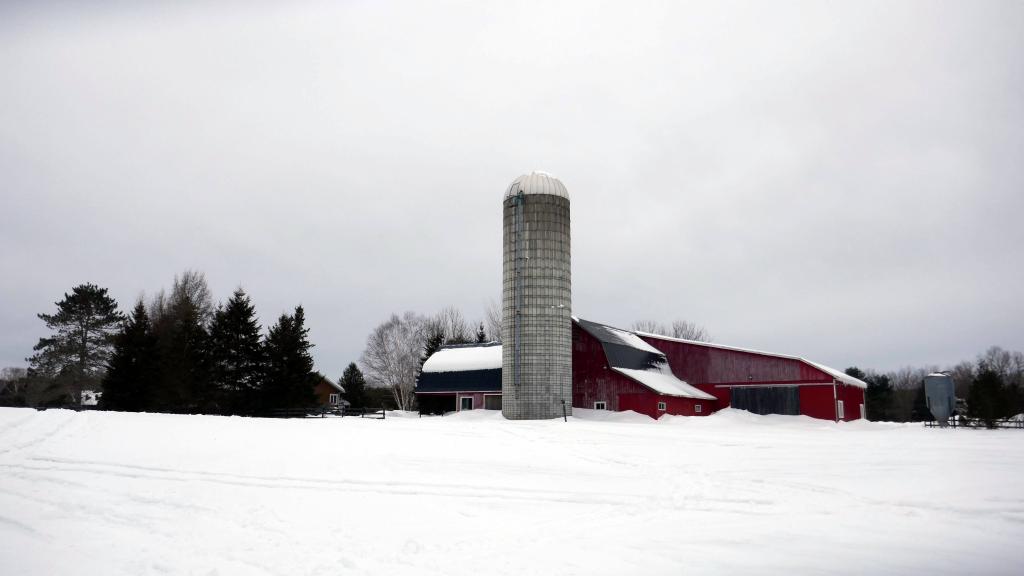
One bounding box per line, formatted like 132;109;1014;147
416;318;867;420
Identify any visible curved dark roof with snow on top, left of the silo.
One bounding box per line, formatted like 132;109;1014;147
416;342;502;393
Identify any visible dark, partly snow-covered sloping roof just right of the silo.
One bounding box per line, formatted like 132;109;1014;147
573;318;715;400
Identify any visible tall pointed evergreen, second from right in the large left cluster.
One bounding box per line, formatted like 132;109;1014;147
209;288;263;414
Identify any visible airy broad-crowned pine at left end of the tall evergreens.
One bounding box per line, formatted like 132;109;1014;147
28;284;124;404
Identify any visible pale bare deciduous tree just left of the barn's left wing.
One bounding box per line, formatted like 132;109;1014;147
359;312;427;410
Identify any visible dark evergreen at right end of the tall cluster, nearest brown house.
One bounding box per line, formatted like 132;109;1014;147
261;306;316;411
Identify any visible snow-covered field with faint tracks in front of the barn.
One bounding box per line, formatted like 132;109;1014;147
0;409;1024;576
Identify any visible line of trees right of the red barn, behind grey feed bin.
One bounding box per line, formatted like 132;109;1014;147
846;346;1024;422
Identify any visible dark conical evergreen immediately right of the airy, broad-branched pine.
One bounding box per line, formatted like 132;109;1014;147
99;300;158;412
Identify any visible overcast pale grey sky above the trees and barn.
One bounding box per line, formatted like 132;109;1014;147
0;1;1024;377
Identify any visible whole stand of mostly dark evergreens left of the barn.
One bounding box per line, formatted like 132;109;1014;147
7;271;342;415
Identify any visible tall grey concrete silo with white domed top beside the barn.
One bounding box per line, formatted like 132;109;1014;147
502;172;572;420
